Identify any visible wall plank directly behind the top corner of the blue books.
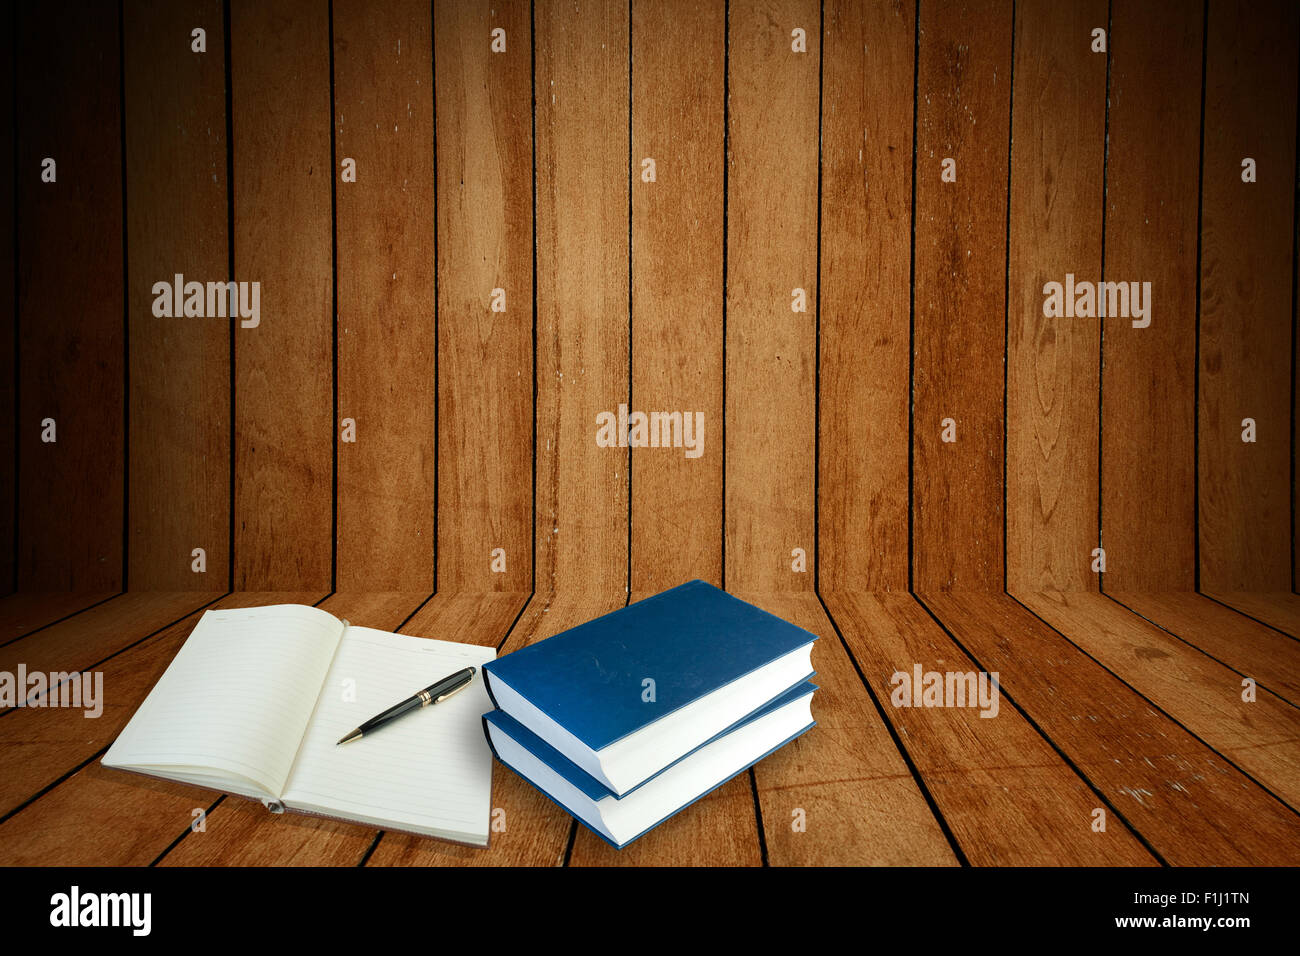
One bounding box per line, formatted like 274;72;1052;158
629;0;727;593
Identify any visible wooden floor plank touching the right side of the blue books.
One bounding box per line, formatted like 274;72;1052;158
737;592;957;866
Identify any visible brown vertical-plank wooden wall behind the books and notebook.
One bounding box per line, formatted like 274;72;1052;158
0;0;1296;608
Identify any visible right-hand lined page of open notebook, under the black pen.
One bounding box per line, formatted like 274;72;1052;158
285;627;497;844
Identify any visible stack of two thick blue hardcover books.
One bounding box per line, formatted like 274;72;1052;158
484;581;816;849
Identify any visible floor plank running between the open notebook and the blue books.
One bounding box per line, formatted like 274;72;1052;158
367;594;624;866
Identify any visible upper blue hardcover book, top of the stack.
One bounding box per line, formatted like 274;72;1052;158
484;580;816;796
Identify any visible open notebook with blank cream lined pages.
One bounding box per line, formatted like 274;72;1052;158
104;605;495;845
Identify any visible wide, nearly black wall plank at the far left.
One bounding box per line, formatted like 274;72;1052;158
14;3;126;591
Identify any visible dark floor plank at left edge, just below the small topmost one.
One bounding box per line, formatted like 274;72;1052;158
0;591;221;686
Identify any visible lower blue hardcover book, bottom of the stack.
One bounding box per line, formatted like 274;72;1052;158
484;682;816;849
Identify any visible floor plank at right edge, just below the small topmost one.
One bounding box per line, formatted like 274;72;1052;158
1106;591;1300;705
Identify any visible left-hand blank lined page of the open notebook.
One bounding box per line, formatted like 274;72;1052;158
104;605;343;797
